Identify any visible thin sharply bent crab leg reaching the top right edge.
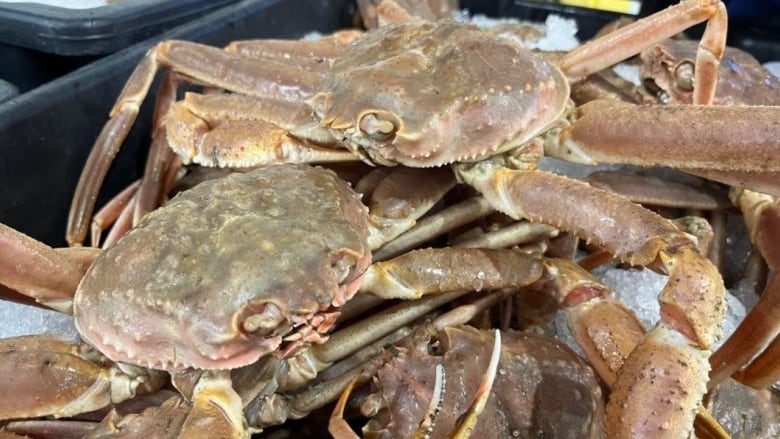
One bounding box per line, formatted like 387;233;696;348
558;0;728;105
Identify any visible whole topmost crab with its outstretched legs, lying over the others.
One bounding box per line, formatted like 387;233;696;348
44;0;780;437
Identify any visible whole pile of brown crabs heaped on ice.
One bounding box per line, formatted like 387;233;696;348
0;0;780;438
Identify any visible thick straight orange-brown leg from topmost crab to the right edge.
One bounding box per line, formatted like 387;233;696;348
545;101;780;178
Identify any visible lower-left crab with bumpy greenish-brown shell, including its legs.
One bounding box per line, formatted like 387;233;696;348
0;165;624;436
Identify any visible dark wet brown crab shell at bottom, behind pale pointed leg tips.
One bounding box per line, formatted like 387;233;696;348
363;326;604;439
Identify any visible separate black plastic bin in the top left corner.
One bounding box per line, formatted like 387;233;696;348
0;0;237;91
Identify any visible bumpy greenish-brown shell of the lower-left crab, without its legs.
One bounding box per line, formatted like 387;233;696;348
74;165;370;370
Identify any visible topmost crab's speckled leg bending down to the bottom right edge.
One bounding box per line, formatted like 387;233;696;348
459;166;726;438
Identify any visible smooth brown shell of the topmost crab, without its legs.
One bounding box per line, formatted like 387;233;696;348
308;20;569;167
